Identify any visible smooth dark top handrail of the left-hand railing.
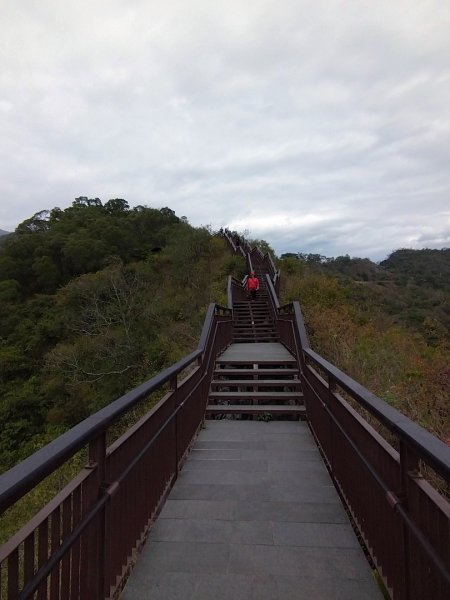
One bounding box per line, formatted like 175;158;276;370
0;303;229;514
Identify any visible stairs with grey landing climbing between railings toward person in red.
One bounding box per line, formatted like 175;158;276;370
206;260;305;420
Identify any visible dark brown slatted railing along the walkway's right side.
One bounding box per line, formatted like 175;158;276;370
268;294;450;600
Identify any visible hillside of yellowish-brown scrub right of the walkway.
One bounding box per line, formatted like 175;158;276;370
279;249;450;441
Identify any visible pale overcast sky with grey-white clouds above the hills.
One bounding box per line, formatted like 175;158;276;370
0;0;450;260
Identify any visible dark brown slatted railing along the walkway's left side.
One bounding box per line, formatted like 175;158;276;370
0;304;232;600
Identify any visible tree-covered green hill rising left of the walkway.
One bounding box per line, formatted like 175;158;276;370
0;197;243;472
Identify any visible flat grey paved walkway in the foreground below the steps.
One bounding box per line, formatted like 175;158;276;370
121;420;382;600
